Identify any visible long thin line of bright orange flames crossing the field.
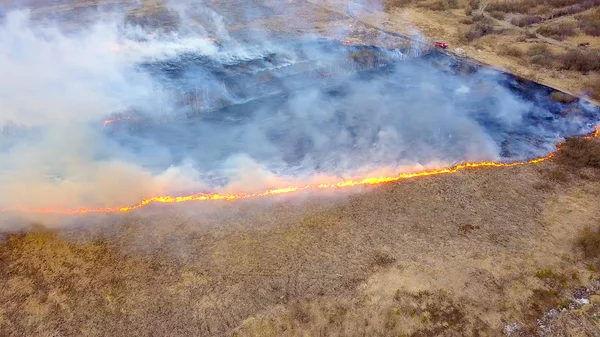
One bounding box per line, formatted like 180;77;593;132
0;126;600;215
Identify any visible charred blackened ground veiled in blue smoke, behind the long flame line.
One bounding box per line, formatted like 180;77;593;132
107;40;600;186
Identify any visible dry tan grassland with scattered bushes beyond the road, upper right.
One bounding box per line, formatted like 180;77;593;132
370;0;600;102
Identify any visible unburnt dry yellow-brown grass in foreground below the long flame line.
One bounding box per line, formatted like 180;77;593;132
0;146;600;336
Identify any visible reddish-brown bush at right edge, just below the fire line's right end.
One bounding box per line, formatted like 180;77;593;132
557;137;600;168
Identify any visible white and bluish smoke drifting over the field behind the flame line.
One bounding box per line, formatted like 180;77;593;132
0;1;595;213
